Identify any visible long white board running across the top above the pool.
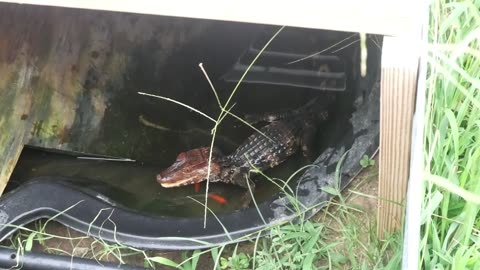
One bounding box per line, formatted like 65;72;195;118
0;0;417;36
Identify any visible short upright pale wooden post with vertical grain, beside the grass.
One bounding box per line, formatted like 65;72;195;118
377;37;419;238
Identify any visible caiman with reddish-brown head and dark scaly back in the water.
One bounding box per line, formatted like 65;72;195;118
157;97;328;193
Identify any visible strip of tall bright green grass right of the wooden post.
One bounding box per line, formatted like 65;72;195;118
419;0;480;269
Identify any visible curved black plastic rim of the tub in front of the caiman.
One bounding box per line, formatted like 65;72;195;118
0;84;379;249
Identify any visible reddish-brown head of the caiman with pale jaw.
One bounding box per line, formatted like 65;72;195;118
157;147;221;188
